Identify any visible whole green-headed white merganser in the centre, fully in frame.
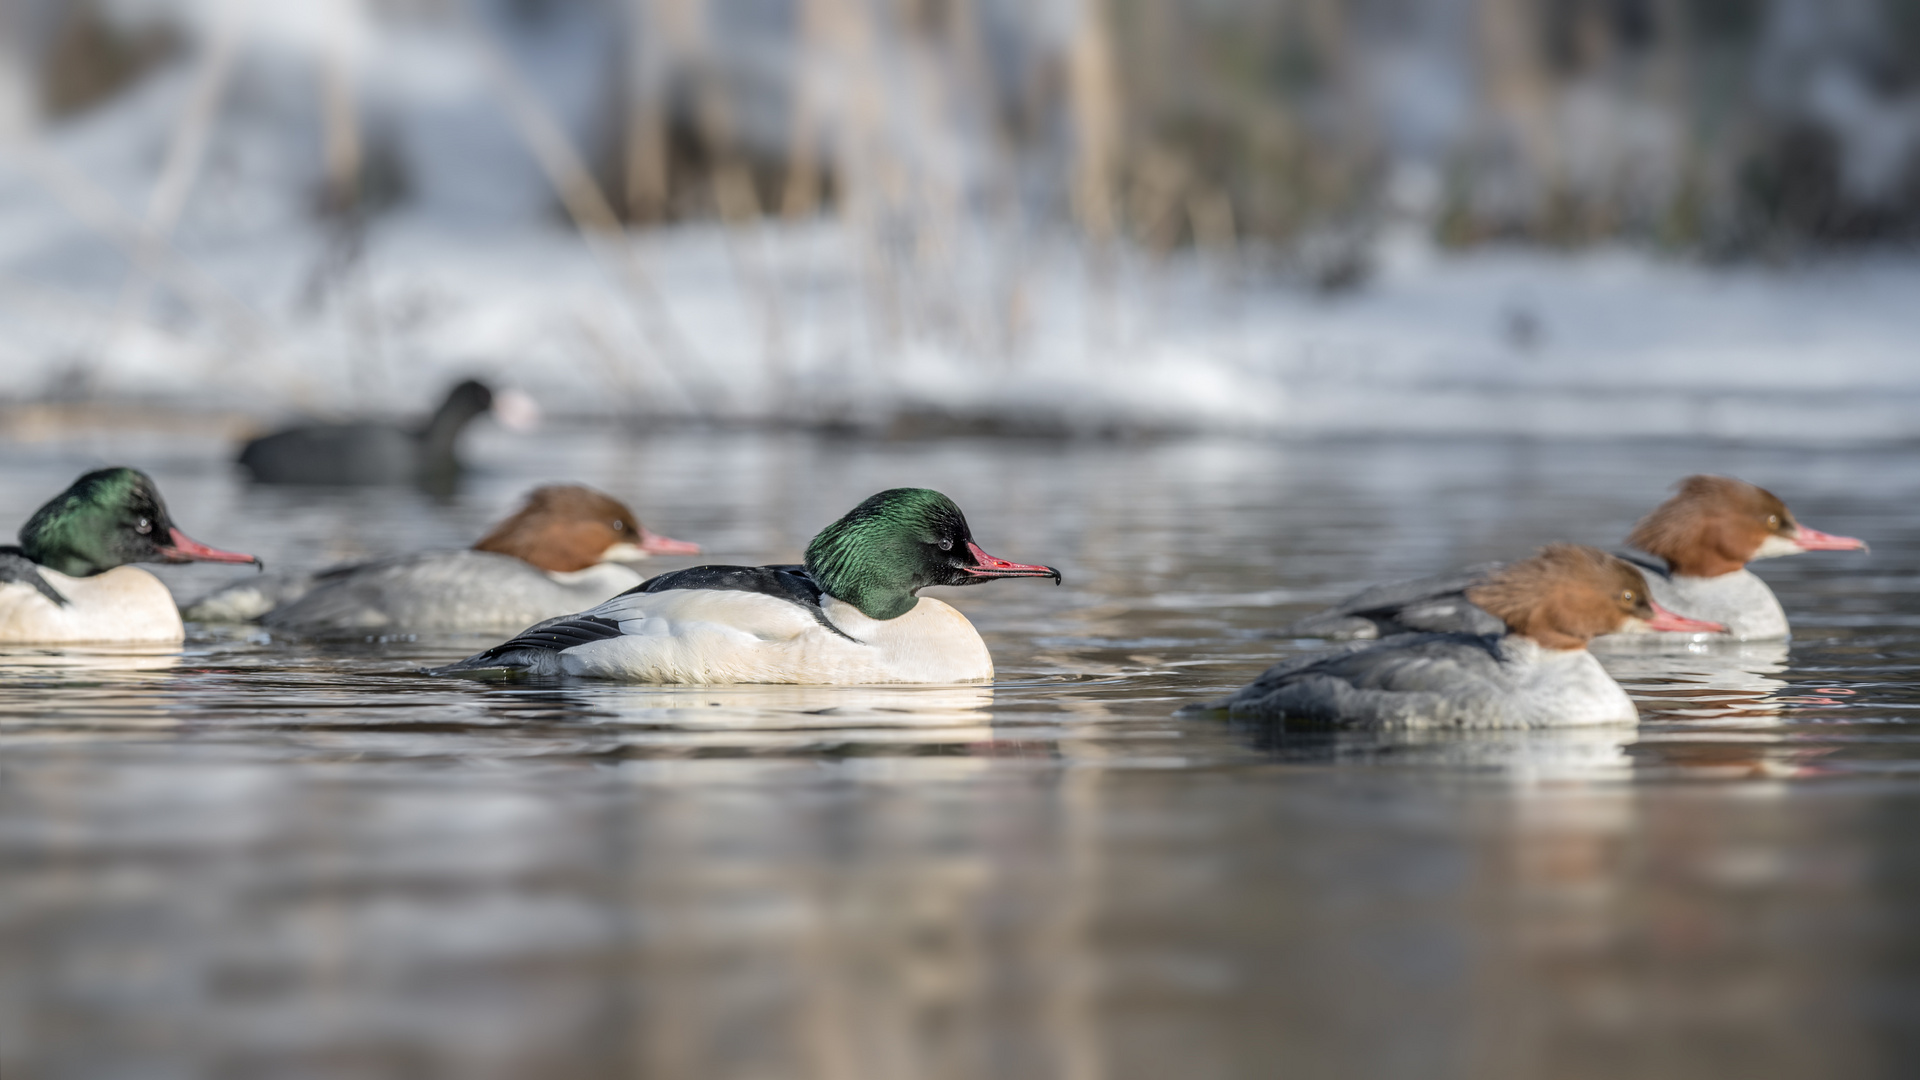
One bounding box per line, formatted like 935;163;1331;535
434;488;1060;684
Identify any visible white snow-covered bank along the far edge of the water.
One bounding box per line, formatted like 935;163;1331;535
0;53;1920;440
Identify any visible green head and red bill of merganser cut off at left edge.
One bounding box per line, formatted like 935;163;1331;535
19;467;259;578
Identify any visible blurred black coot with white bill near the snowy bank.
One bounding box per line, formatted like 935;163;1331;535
238;379;538;484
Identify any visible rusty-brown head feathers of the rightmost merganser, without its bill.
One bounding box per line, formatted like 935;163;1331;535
1626;468;1799;578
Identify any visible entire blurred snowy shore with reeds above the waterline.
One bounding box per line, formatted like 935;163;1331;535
0;0;1920;442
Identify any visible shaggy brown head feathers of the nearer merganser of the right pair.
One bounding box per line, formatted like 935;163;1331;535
1467;544;1653;650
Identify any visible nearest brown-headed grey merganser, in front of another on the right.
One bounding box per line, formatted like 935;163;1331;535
1206;544;1720;728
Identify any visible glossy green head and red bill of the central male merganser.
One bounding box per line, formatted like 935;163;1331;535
806;488;1060;619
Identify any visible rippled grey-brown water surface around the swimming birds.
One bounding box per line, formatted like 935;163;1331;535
0;430;1920;1080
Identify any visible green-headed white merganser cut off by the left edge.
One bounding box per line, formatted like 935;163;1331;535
0;469;259;644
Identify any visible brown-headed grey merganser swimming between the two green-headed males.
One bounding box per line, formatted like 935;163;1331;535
184;484;701;636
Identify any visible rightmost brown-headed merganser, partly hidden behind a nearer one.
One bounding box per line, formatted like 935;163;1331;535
1283;477;1866;642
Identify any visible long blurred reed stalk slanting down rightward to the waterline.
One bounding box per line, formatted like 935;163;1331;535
468;21;726;415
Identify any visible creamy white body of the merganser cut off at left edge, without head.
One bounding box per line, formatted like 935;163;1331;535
0;567;186;644
